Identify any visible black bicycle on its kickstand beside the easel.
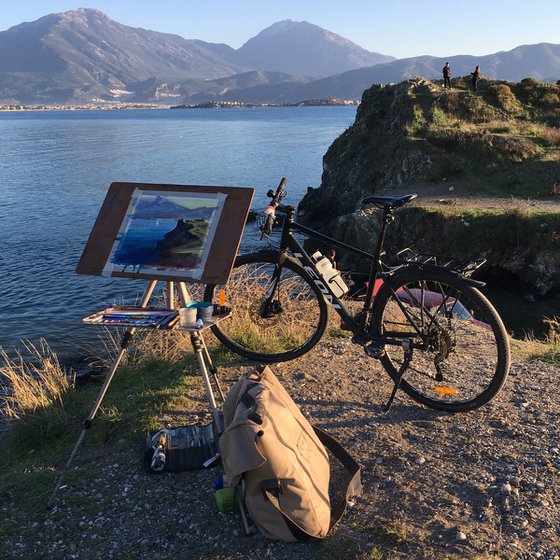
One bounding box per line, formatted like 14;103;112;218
205;178;510;412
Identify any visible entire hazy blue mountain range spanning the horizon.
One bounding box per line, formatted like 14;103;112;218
0;8;560;105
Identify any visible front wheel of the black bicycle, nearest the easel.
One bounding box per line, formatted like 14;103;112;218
205;251;328;363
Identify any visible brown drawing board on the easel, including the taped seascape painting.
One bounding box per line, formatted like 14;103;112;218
77;183;253;283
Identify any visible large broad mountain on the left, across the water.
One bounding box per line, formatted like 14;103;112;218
0;8;245;103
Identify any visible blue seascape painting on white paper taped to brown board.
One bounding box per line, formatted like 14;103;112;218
103;189;226;279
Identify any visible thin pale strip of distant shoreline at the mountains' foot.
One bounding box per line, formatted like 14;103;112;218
0;97;360;111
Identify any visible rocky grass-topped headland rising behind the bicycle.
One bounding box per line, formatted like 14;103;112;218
299;78;560;294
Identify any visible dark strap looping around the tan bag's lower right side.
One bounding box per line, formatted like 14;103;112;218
262;426;362;541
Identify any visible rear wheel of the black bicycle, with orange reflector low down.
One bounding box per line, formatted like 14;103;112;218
372;267;510;412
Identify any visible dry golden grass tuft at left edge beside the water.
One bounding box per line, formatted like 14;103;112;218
0;339;73;419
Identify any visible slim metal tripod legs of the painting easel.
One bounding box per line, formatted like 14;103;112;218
47;280;224;507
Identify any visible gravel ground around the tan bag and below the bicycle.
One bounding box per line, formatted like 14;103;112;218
0;339;560;560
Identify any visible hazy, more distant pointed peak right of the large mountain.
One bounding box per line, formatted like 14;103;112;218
231;19;395;77
